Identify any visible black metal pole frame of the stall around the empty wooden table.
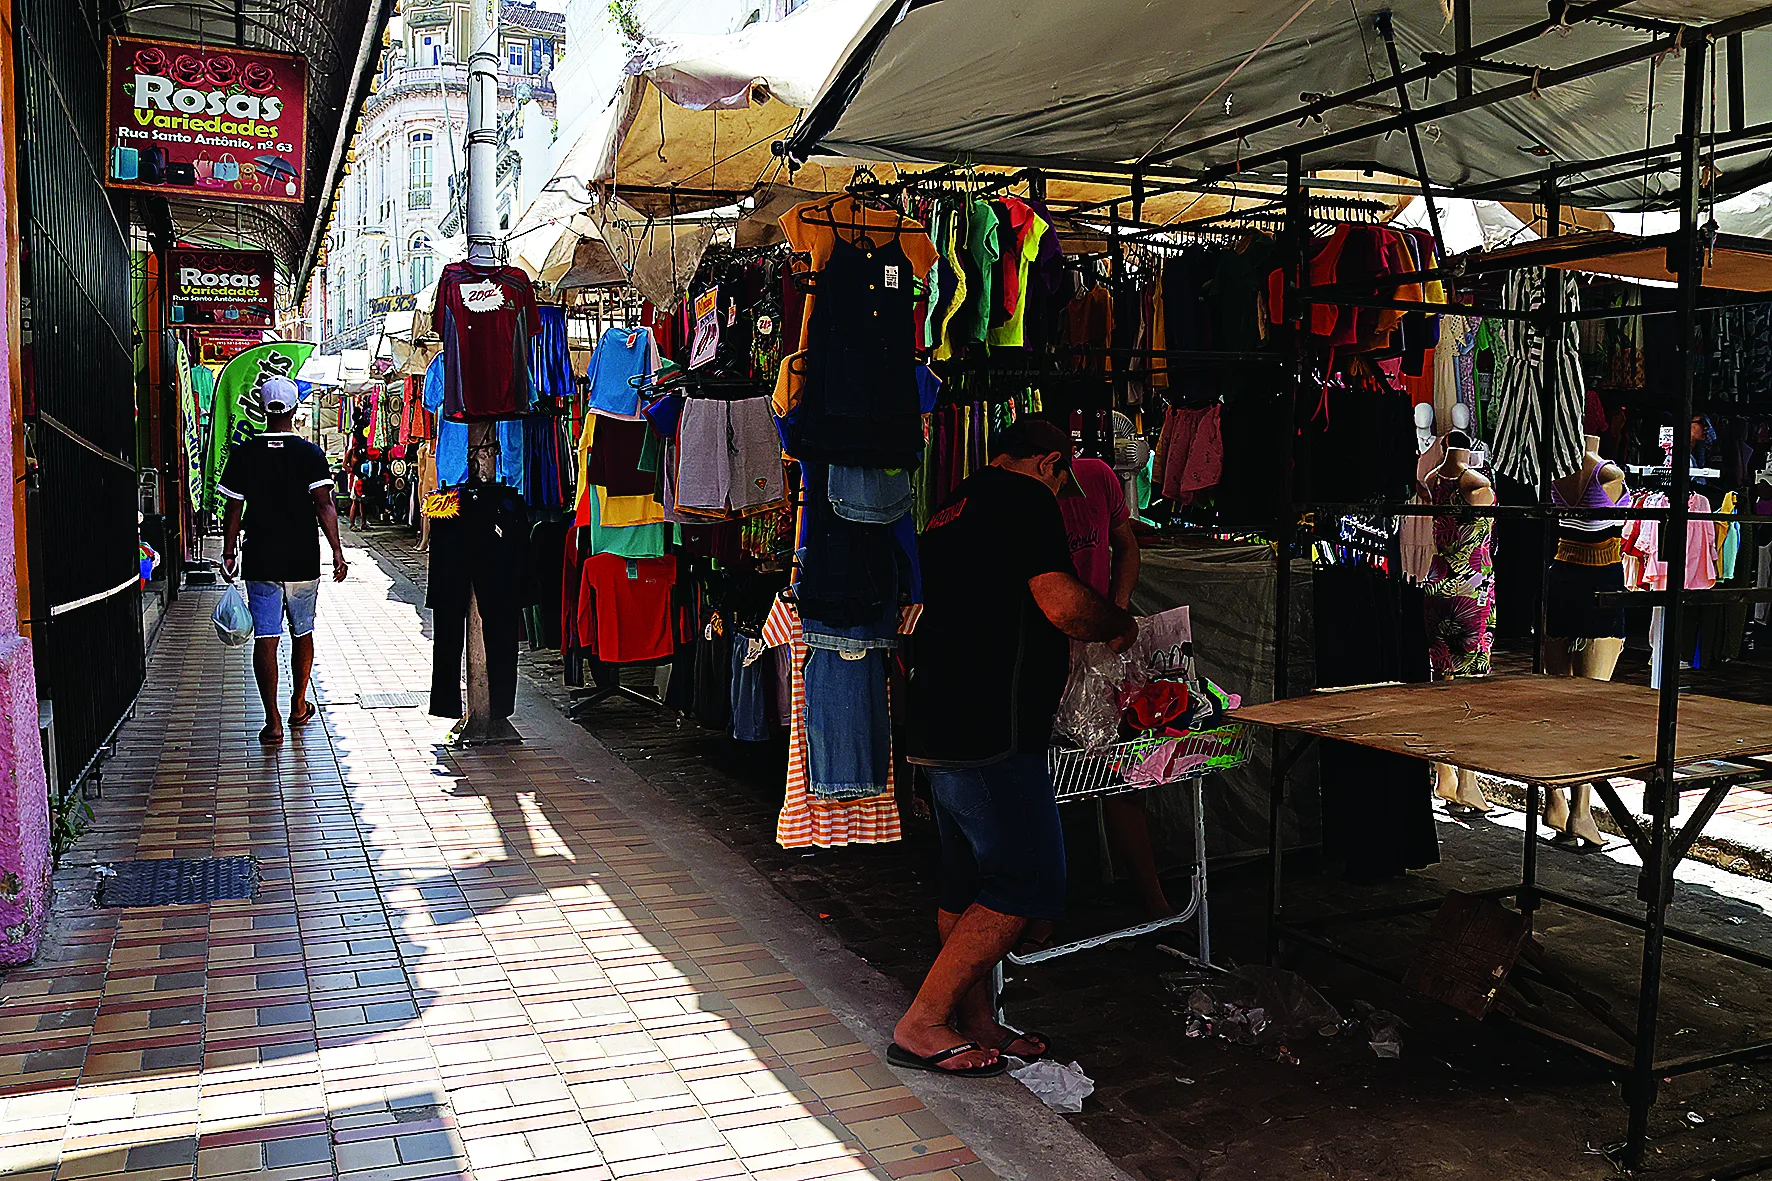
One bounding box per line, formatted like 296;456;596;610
1247;11;1772;1176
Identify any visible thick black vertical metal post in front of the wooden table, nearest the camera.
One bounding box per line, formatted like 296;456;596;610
1625;39;1710;1169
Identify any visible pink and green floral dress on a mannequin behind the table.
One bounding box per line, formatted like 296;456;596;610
1421;472;1496;679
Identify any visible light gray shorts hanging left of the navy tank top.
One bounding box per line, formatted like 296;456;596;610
677;397;787;512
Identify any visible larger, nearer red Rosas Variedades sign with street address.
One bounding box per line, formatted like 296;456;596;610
105;37;308;202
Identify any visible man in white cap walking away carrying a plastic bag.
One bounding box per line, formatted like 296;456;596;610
216;378;349;747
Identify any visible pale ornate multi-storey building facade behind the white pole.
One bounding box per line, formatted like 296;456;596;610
308;0;565;353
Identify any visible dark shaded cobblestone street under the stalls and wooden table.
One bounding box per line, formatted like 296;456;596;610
352;534;1772;1181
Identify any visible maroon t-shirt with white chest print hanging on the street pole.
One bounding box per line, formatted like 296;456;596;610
434;262;542;422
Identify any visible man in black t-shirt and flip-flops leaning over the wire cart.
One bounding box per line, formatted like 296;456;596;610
888;418;1138;1076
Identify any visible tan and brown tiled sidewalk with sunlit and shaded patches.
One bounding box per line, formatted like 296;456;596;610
0;550;994;1181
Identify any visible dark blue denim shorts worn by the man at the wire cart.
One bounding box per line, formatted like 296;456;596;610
923;754;1065;922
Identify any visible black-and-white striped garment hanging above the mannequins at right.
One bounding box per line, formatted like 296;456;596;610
1488;268;1588;488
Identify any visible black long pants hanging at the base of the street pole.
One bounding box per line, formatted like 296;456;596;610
425;484;533;718
